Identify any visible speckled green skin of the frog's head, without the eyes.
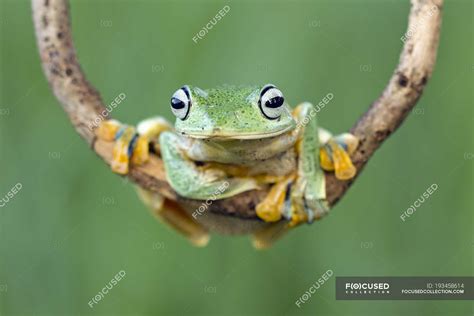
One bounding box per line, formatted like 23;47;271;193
175;86;295;139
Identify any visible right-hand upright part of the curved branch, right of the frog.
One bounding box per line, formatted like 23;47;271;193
326;0;443;204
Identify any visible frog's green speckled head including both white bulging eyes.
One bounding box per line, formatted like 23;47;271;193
171;84;295;139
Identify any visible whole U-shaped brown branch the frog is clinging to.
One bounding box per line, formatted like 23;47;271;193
32;0;443;219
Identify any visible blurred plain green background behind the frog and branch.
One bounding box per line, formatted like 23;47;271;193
0;0;474;315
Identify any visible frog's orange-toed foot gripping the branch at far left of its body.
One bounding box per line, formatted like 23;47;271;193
96;117;171;174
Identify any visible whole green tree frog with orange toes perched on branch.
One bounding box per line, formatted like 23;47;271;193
97;84;358;248
